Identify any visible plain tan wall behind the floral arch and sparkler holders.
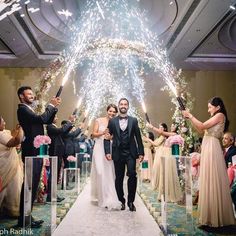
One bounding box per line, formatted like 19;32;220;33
0;68;236;133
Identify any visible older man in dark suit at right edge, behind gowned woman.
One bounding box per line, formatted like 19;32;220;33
222;132;236;168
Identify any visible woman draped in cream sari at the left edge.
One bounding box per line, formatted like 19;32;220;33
0;116;23;217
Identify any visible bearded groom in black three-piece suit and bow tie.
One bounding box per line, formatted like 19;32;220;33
104;98;144;211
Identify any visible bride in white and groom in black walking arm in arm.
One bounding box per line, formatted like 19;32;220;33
91;98;144;211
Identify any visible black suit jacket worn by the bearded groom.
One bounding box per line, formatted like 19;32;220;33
104;116;144;161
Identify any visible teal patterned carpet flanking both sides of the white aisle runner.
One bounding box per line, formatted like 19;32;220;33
0;175;236;236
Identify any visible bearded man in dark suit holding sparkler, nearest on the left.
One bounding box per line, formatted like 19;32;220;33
17;86;61;228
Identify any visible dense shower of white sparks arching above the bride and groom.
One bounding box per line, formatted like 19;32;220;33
56;0;179;121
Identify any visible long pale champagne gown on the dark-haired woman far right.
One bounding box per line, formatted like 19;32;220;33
198;120;235;227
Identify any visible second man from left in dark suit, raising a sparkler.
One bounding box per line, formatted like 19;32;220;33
46;115;75;202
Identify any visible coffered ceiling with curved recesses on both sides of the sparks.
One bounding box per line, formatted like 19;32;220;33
0;0;236;70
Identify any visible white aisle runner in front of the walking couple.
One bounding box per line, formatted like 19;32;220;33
53;184;161;236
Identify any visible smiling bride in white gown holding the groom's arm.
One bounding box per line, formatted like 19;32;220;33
91;104;121;209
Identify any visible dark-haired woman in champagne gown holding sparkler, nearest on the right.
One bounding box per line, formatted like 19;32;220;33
182;97;235;227
